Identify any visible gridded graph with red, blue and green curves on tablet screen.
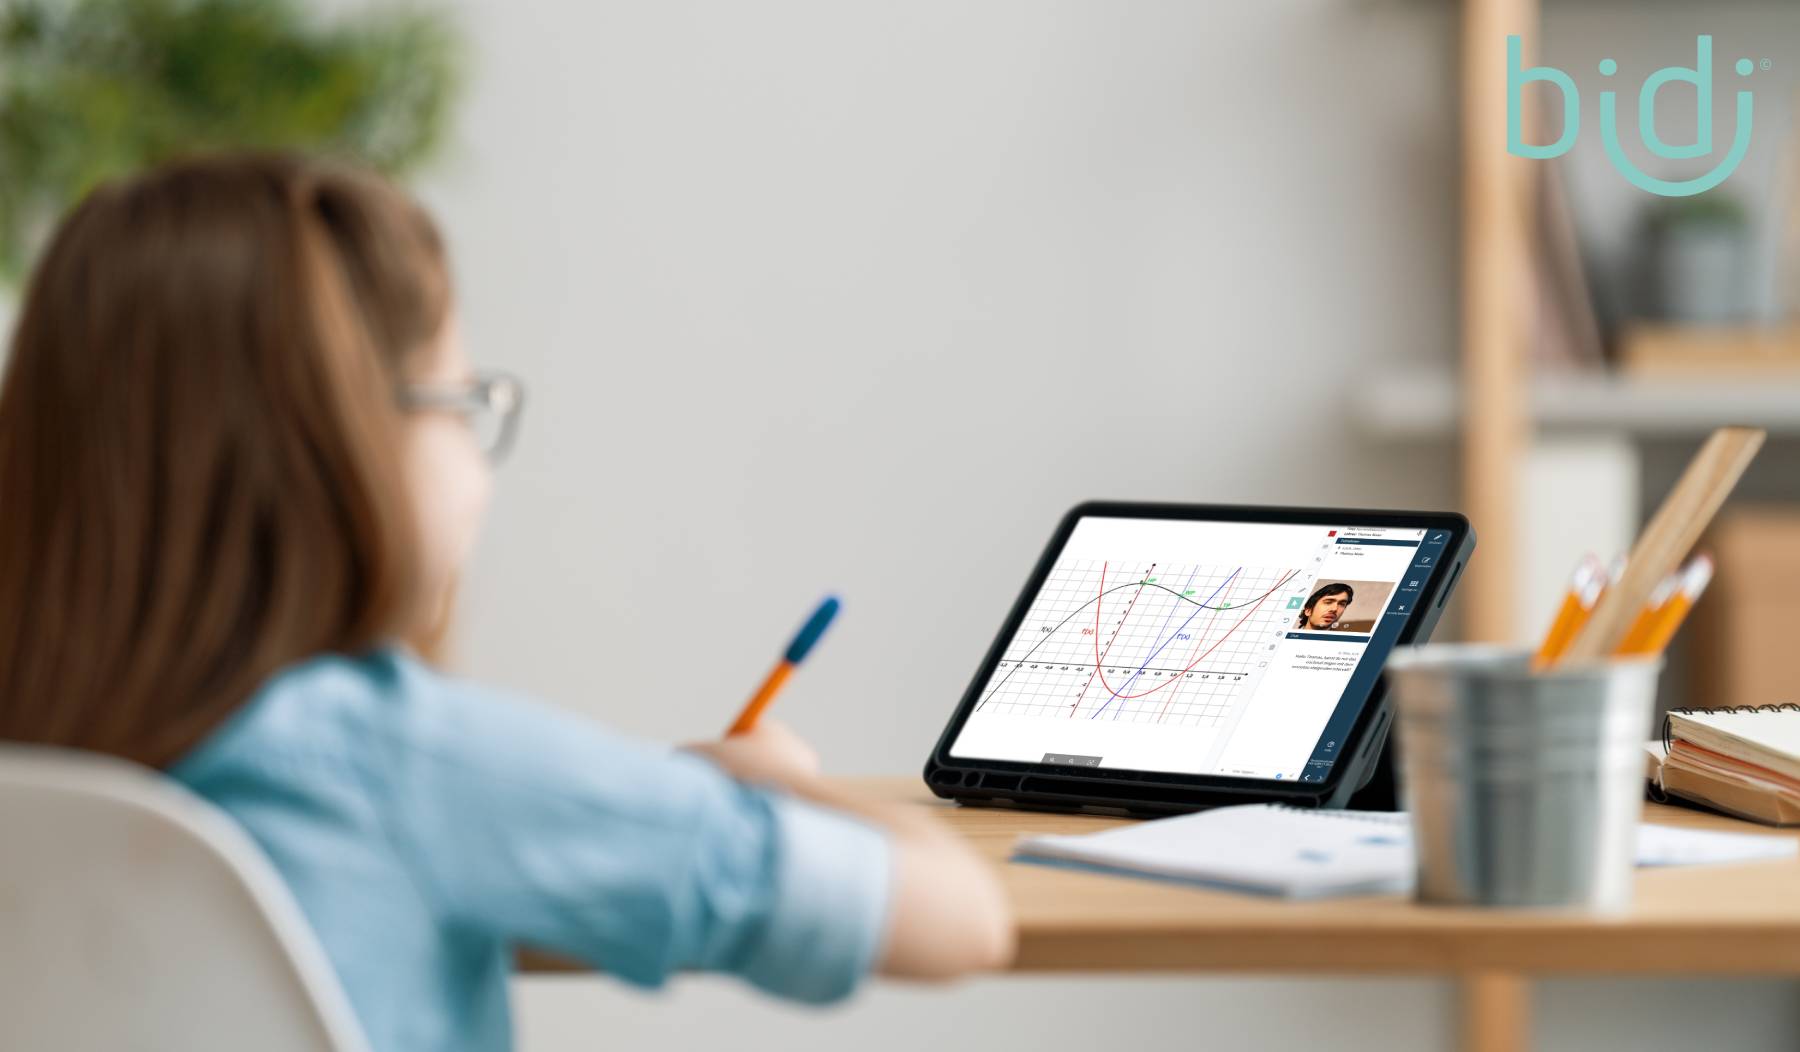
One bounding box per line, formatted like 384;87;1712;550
976;560;1307;726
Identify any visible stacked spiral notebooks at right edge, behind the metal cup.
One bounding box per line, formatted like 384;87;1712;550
1649;704;1800;825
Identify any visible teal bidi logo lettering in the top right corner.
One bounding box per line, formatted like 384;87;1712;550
1507;36;1768;196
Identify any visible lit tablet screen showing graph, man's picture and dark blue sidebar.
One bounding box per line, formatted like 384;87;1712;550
950;517;1451;782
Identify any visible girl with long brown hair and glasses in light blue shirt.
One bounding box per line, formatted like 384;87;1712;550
0;155;1012;1050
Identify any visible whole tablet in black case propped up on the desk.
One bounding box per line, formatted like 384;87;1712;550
925;503;1474;812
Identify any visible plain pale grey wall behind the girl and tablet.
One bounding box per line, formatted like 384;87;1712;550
417;0;1795;1052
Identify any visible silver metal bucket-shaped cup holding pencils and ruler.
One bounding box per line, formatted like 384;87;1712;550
1388;645;1663;911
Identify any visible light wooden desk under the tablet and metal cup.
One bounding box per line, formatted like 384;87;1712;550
533;778;1800;1052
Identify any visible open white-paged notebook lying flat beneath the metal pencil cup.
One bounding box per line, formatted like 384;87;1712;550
1013;803;1800;899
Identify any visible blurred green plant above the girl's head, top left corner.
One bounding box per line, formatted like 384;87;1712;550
0;0;461;283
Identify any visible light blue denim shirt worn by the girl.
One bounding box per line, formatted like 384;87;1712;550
169;650;891;1052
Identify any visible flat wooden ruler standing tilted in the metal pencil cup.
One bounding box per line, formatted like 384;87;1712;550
1557;427;1768;665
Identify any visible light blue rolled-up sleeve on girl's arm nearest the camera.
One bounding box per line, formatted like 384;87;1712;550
374;672;893;1003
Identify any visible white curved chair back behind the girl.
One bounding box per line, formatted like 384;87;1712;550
0;744;367;1052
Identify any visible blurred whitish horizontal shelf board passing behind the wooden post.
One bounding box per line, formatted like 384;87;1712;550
1354;369;1800;441
